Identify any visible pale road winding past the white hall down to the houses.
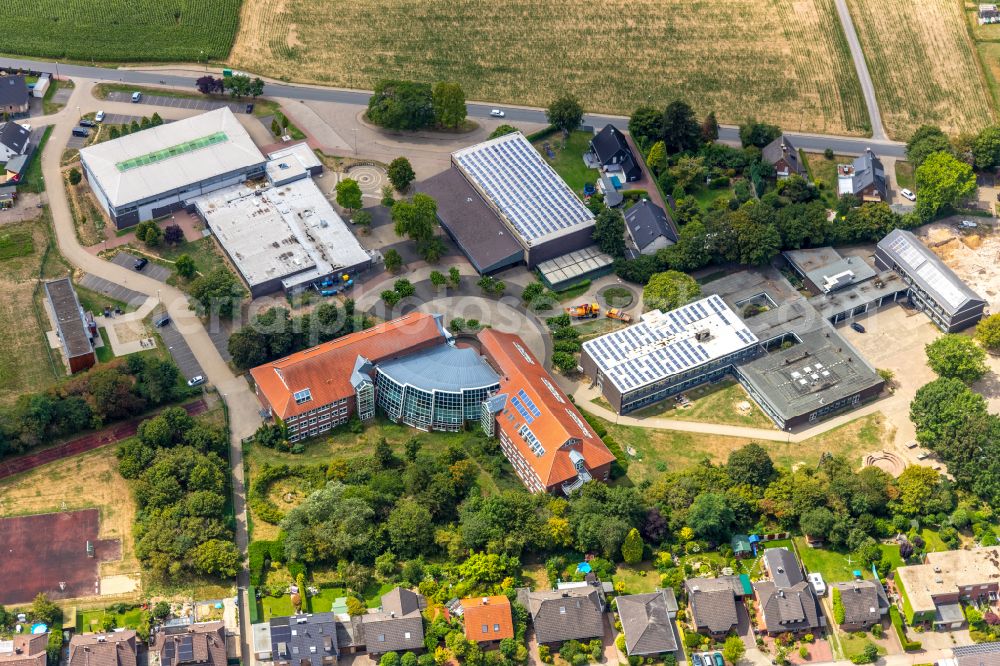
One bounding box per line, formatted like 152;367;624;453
33;78;261;654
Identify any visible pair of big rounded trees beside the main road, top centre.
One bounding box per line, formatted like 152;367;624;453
367;79;466;130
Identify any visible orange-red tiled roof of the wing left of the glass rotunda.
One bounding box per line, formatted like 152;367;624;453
250;312;445;419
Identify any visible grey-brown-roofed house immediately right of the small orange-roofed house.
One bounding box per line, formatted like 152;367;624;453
518;585;604;645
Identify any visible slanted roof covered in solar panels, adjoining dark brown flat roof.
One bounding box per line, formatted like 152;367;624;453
454;132;594;245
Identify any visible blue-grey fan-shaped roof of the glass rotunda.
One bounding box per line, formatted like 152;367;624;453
377;344;500;393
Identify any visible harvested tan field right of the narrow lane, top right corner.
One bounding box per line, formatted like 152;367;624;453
848;0;994;140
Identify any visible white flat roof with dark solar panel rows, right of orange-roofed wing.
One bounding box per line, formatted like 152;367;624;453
583;294;758;392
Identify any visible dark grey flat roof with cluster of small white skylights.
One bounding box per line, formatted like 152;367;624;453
738;322;884;420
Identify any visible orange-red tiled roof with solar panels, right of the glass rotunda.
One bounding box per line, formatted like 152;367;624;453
479;328;615;488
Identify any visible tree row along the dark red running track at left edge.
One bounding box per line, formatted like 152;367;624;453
0;355;188;458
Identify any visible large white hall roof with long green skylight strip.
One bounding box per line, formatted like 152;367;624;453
80;107;264;208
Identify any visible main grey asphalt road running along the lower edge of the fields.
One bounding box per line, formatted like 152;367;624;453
0;58;906;157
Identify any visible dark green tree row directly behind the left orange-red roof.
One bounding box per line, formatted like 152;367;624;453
229;298;372;369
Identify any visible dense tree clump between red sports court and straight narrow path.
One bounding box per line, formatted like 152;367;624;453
118;407;240;580
